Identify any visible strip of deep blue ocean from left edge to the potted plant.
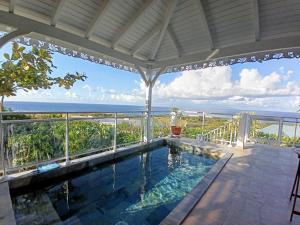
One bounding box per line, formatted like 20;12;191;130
4;101;170;112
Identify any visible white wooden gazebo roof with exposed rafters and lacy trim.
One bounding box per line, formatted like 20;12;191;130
0;0;300;72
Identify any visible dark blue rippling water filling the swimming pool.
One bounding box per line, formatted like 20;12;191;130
12;147;216;225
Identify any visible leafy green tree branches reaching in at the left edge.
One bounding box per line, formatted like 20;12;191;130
0;43;86;112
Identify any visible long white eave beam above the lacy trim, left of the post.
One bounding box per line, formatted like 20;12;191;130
0;11;148;68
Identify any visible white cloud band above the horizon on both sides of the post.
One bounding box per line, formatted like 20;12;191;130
5;66;300;111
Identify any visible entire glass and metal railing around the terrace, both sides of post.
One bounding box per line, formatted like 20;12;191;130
0;111;300;175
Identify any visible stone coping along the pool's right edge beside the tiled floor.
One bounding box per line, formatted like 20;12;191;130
160;152;233;225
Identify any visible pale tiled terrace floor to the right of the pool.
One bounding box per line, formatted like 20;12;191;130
183;146;300;225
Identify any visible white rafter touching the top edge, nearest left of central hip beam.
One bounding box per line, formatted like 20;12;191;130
112;0;155;48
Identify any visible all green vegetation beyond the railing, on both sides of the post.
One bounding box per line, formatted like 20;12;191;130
5;114;232;166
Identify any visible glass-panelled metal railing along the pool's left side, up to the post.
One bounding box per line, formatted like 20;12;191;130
0;111;168;174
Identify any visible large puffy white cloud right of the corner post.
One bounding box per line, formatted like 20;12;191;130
141;66;300;100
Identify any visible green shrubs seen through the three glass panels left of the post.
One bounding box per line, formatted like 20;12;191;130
5;120;141;166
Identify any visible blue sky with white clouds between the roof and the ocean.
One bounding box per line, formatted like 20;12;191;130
0;41;300;112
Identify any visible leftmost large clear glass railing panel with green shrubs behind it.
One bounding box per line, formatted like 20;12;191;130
3;119;65;172
